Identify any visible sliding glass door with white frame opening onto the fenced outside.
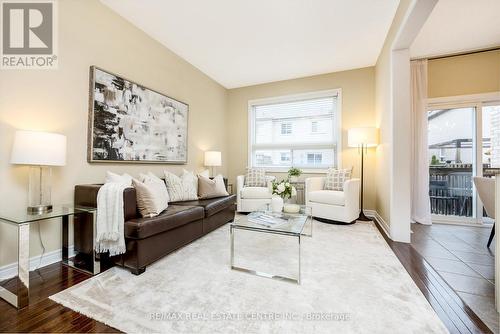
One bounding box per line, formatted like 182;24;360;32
428;102;500;224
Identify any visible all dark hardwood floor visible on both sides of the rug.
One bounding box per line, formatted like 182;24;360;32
0;225;492;333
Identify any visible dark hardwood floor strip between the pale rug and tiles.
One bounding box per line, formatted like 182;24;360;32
376;224;492;333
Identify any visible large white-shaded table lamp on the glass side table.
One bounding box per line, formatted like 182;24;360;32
10;130;66;214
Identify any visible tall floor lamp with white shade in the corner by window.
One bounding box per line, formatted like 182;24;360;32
347;127;378;221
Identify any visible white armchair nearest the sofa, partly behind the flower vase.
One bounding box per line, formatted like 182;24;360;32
236;175;275;212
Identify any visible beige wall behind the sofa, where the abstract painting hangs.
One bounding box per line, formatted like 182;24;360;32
0;0;230;266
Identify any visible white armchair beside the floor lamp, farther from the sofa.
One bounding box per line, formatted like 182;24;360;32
305;177;361;224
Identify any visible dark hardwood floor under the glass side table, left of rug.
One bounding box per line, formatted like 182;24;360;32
0;263;118;333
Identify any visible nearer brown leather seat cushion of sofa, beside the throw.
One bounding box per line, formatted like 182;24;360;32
125;205;204;239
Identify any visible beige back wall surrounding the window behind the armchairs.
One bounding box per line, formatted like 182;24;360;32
227;67;375;209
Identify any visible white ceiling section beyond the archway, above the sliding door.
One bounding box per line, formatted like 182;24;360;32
410;0;500;57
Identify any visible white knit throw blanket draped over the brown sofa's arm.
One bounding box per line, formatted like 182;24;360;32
95;182;128;256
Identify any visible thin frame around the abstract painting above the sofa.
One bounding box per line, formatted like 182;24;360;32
87;65;189;165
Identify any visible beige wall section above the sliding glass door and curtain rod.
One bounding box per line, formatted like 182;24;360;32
428;50;500;98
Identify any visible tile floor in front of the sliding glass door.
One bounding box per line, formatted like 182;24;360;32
411;224;500;333
